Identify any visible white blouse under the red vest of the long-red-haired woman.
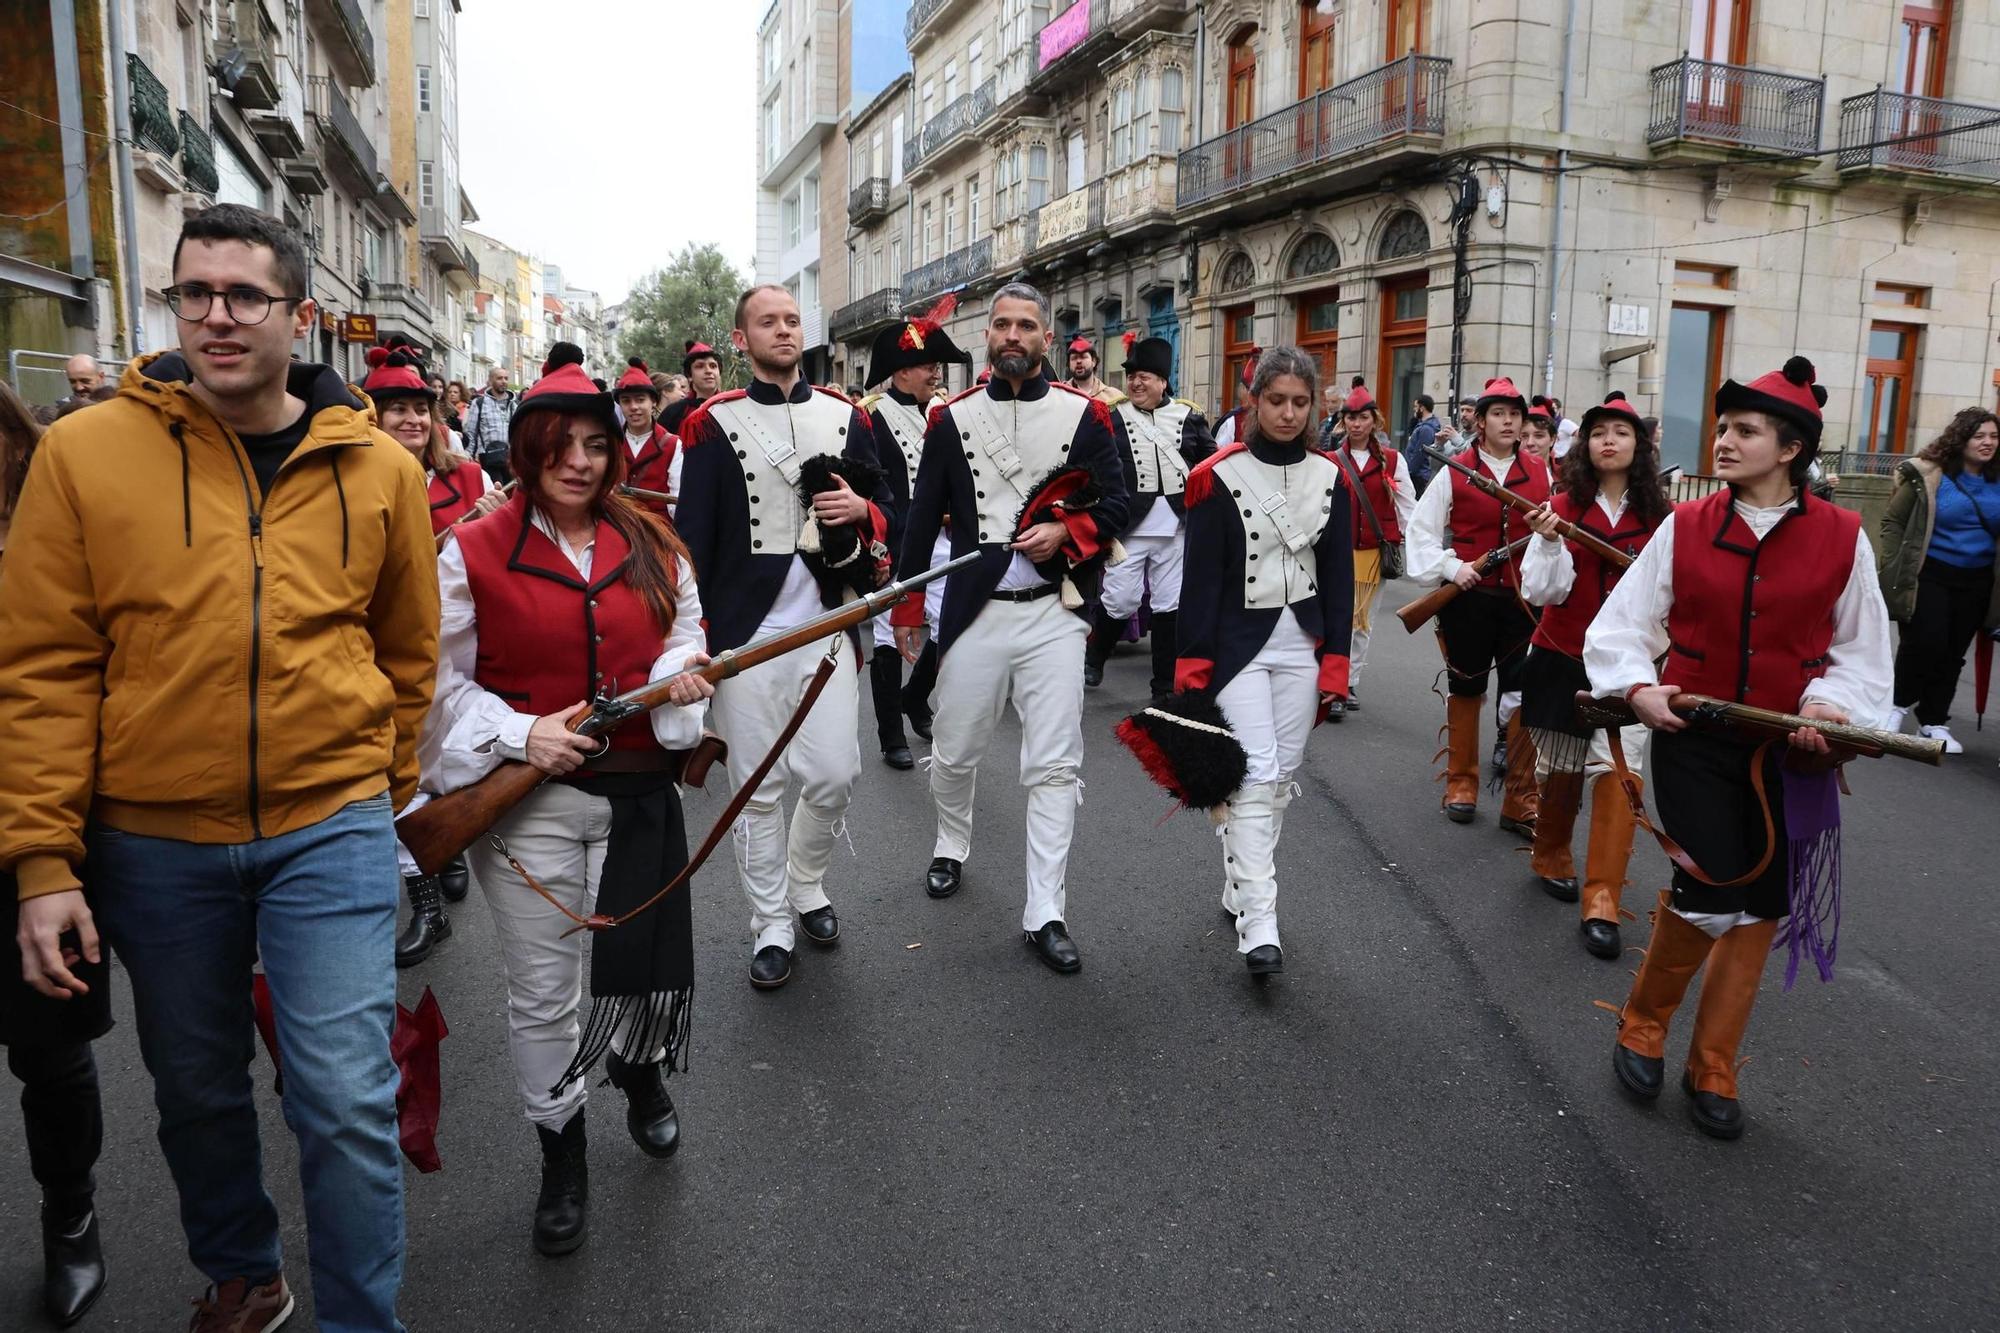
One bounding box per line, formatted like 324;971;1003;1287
418;510;708;791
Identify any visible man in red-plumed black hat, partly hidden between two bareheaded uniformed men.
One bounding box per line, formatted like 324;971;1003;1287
858;296;966;769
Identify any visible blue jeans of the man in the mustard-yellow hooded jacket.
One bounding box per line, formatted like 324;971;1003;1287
90;793;404;1333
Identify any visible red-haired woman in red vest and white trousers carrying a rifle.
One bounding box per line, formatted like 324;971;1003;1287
424;366;714;1255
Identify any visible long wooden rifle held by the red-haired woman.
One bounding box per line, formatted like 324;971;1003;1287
396;550;980;875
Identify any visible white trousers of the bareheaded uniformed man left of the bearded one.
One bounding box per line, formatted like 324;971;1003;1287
708;634;862;953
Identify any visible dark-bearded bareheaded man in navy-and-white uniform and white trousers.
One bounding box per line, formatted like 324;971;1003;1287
890;282;1126;973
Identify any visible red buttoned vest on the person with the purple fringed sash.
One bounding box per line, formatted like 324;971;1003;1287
1660;490;1862;713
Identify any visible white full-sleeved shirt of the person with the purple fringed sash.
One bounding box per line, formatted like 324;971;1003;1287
1576;500;1894;727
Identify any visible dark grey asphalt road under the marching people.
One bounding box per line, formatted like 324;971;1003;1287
0;584;2000;1331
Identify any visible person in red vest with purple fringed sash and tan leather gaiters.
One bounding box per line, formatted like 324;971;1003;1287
1584;356;1894;1139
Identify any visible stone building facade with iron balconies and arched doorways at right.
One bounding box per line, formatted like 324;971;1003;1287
834;0;2000;470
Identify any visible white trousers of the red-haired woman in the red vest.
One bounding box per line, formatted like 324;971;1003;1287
466;783;664;1129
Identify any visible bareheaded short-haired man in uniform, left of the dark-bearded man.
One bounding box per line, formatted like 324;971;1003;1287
674;284;892;991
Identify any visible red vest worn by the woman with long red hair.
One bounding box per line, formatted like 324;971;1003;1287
458;492;674;751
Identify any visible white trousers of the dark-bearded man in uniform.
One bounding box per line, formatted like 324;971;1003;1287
930;596;1090;931
